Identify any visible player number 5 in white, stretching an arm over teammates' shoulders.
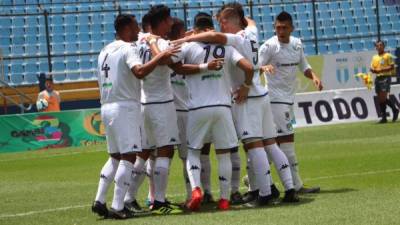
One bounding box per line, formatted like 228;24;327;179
172;3;298;205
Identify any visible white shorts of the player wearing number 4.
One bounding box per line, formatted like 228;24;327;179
101;102;142;154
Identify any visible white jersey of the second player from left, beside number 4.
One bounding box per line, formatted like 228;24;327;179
139;38;174;104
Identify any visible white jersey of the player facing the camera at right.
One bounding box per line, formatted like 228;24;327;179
259;36;311;103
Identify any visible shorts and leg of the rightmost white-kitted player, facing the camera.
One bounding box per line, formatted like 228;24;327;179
271;104;320;193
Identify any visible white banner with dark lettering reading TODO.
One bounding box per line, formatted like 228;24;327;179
293;85;400;127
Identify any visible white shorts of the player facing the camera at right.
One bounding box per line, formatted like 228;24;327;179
271;103;296;136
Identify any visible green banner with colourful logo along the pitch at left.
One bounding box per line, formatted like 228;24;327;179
0;109;105;153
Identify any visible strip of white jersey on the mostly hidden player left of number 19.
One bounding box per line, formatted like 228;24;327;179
171;72;189;111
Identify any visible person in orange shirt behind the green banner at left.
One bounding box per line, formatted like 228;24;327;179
38;76;61;112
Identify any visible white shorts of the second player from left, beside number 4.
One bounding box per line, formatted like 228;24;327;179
142;102;180;149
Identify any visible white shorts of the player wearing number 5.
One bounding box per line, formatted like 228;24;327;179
232;95;276;140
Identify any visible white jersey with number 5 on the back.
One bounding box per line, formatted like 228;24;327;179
226;27;268;97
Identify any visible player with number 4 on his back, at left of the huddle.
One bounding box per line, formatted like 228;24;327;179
92;15;180;219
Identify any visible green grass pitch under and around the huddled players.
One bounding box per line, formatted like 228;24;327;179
0;122;400;225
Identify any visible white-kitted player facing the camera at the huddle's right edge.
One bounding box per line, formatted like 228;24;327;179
259;12;323;193
